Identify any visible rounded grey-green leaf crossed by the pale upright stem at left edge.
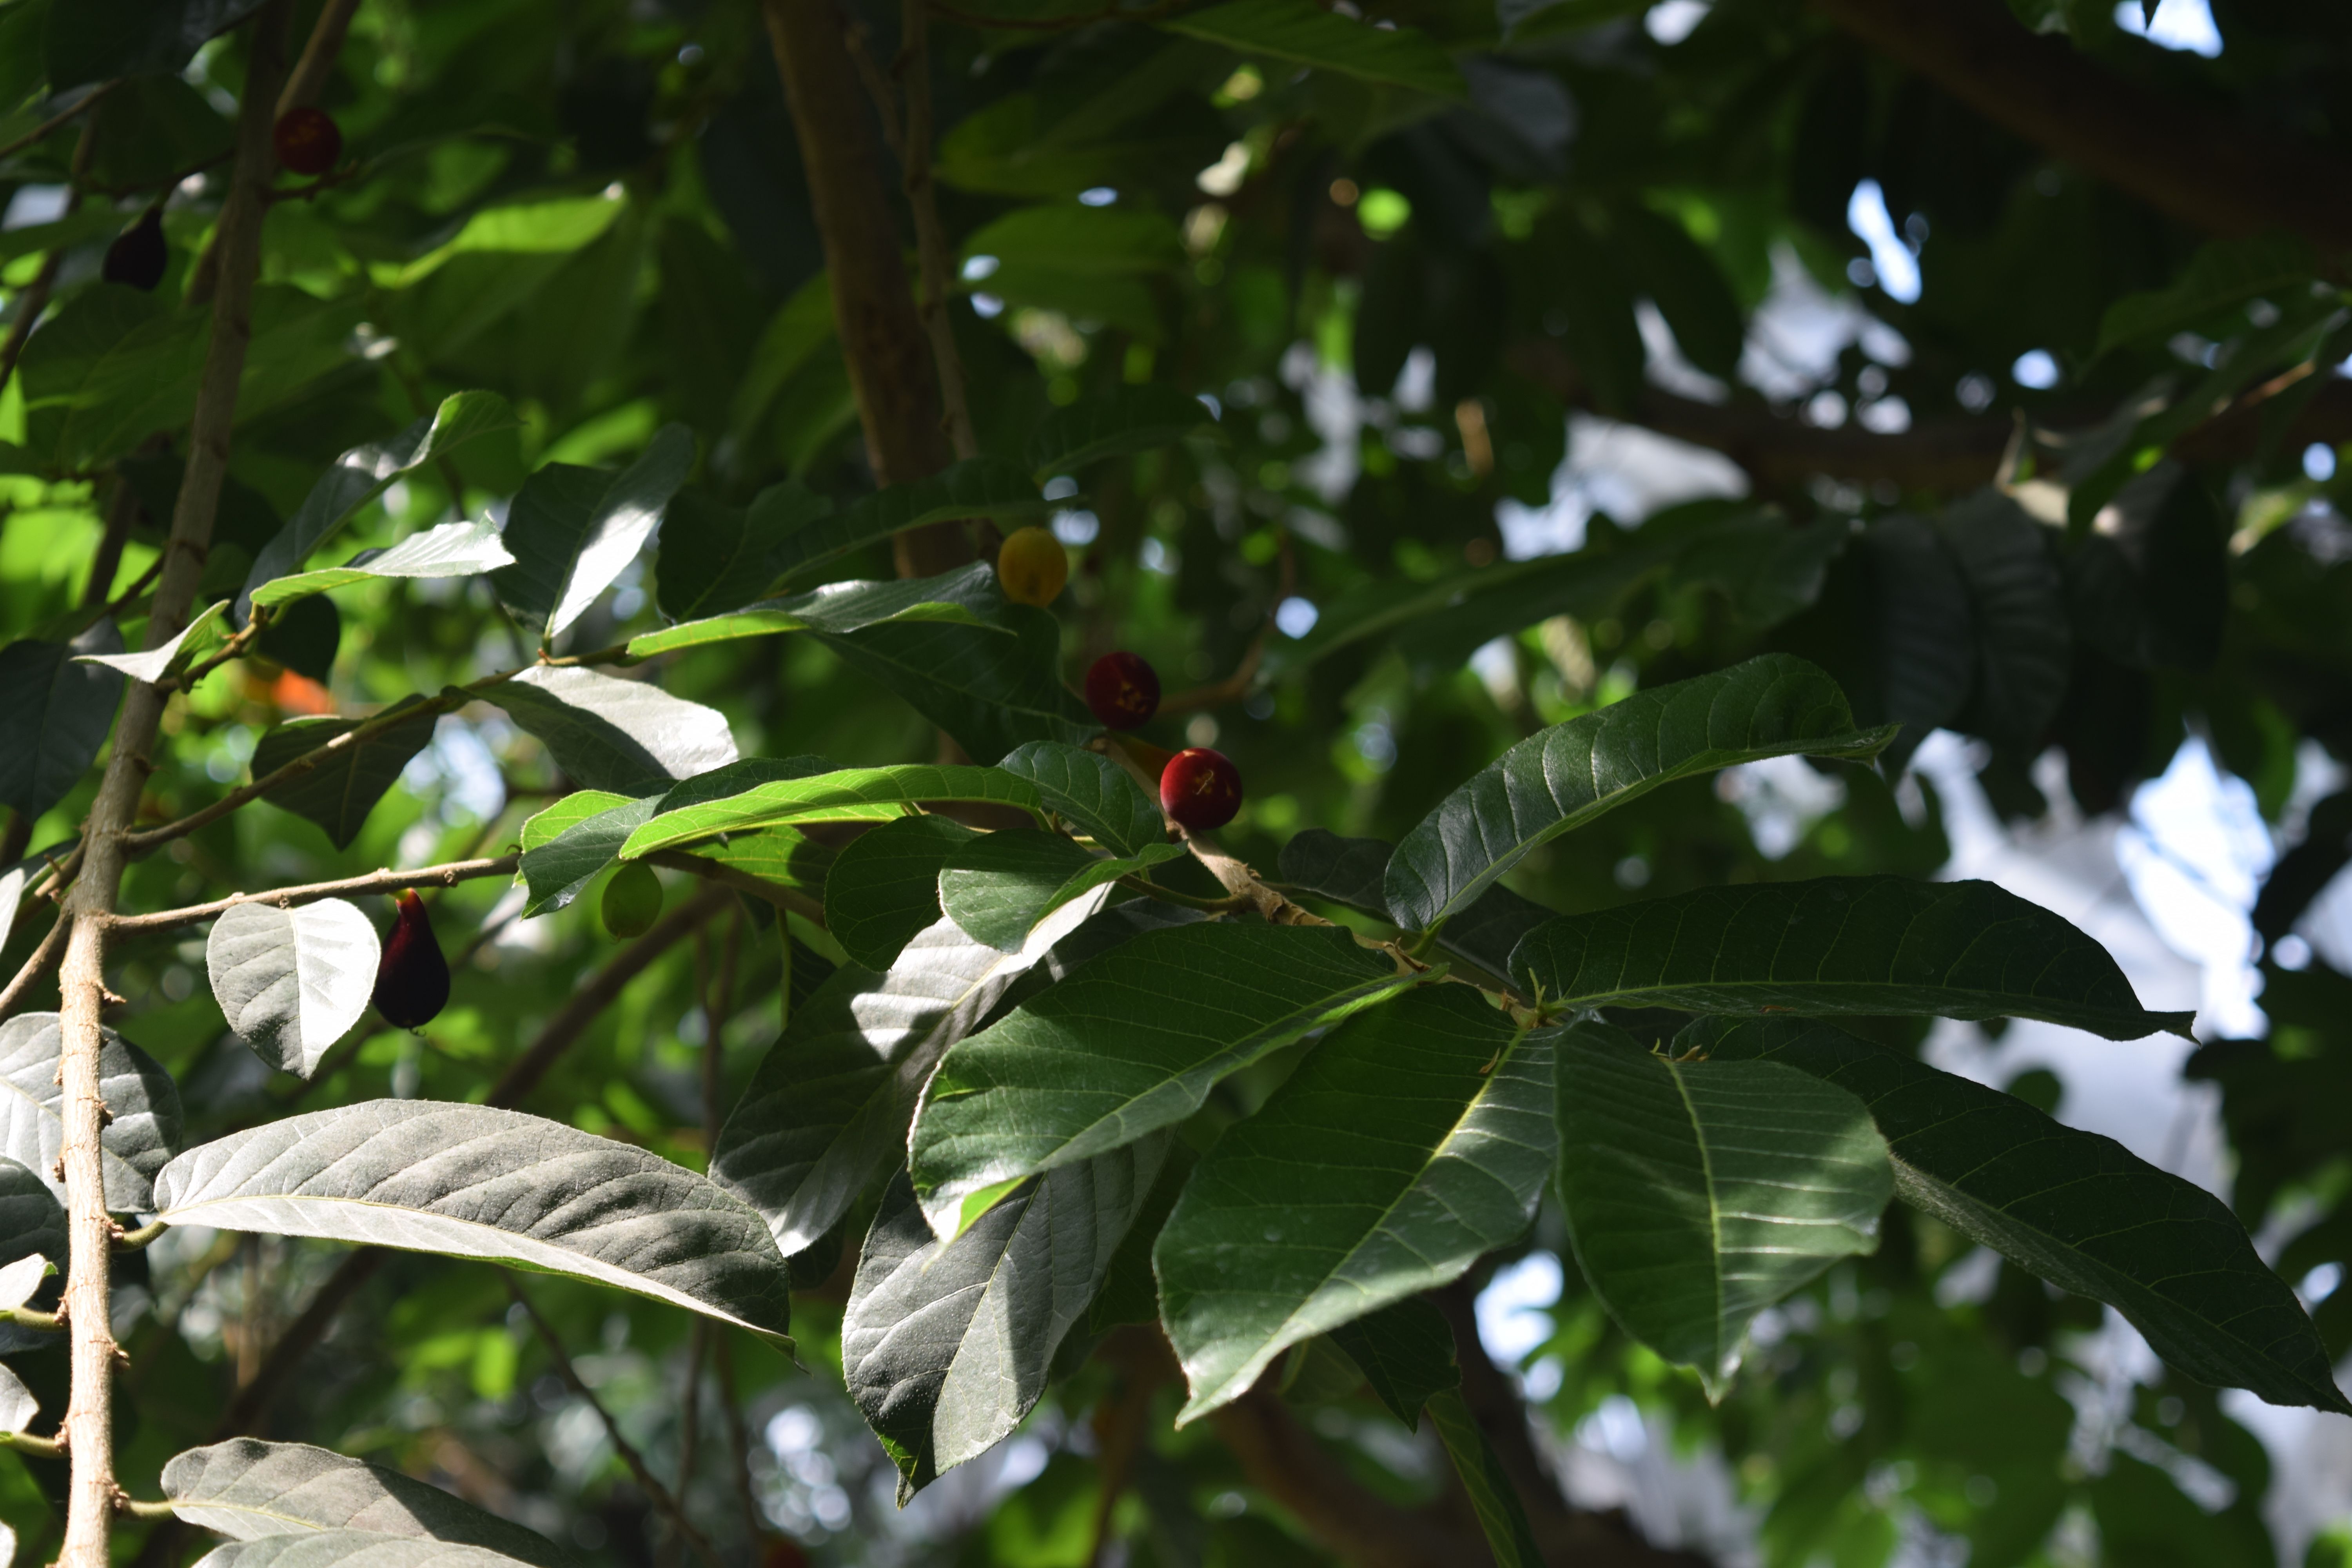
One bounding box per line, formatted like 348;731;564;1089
0;1013;181;1213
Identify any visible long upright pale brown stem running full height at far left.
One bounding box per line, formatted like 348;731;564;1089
56;0;289;1568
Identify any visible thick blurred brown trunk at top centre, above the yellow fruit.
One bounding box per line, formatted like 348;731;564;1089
762;0;971;576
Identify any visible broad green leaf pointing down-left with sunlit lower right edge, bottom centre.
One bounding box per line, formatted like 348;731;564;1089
1152;992;1555;1422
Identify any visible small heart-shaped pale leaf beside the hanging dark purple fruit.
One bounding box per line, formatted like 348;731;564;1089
205;898;383;1079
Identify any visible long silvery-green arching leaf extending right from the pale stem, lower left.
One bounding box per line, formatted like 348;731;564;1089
155;1100;790;1347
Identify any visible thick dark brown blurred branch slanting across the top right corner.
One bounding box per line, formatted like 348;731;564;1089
1813;0;2352;254
